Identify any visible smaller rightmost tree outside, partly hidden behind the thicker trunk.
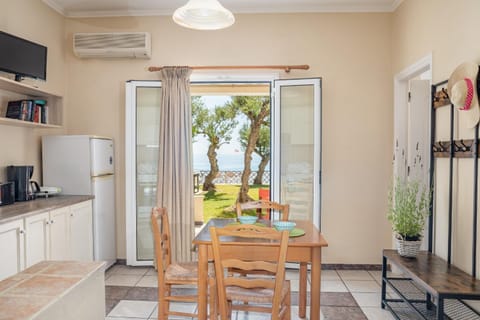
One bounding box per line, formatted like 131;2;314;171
239;118;270;184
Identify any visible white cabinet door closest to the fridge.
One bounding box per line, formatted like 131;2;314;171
70;201;93;261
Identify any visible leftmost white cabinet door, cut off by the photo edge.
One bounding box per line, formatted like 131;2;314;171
0;219;25;280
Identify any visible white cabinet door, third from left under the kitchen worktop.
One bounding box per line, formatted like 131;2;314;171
50;207;70;260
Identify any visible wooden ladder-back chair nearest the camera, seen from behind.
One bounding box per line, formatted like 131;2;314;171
210;225;290;320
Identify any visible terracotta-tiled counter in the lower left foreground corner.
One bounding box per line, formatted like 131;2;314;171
0;261;105;320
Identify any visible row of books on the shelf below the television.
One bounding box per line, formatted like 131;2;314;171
5;99;48;123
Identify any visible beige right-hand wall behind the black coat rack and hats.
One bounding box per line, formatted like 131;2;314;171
392;0;480;274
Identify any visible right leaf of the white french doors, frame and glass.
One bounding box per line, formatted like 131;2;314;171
272;78;322;229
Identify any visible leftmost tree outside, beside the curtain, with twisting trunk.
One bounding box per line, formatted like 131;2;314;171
192;103;238;191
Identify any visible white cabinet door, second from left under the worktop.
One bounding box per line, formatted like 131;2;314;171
25;212;50;268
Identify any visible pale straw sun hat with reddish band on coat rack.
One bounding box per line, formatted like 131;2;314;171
447;62;480;128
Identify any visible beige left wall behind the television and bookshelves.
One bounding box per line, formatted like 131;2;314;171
0;0;66;181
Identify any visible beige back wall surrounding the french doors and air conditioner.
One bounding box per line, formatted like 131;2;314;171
65;14;392;263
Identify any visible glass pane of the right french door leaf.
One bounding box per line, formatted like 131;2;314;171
280;85;315;220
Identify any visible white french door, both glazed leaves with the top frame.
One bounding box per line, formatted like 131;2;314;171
125;75;321;266
